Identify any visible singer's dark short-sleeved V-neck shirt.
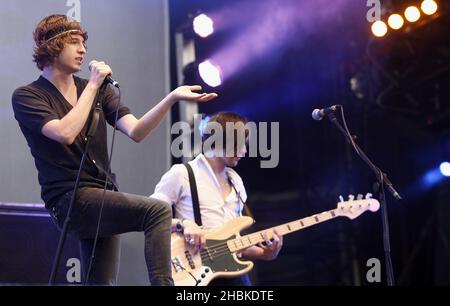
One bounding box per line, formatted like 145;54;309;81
12;76;130;208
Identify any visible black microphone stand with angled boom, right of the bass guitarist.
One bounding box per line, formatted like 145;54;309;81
327;112;402;286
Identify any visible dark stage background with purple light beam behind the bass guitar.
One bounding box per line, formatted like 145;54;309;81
169;0;450;285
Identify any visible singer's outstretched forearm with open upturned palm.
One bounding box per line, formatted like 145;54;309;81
117;86;217;142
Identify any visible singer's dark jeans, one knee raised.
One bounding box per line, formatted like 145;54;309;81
51;187;173;286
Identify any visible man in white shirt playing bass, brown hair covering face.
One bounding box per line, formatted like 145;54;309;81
151;112;283;286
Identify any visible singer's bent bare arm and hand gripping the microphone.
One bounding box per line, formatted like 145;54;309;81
42;62;111;145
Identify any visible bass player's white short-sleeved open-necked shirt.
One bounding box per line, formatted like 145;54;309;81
151;154;247;228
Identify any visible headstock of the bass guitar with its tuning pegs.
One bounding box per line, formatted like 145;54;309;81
335;193;380;219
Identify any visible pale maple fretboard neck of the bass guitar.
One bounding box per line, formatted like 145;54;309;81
227;209;339;252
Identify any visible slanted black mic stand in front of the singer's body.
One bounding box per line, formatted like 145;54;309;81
48;81;108;286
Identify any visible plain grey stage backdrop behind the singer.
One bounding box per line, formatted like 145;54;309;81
0;0;170;285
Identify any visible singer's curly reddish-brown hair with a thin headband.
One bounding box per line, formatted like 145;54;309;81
33;15;88;70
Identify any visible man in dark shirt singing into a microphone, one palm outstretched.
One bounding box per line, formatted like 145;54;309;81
12;15;217;285
